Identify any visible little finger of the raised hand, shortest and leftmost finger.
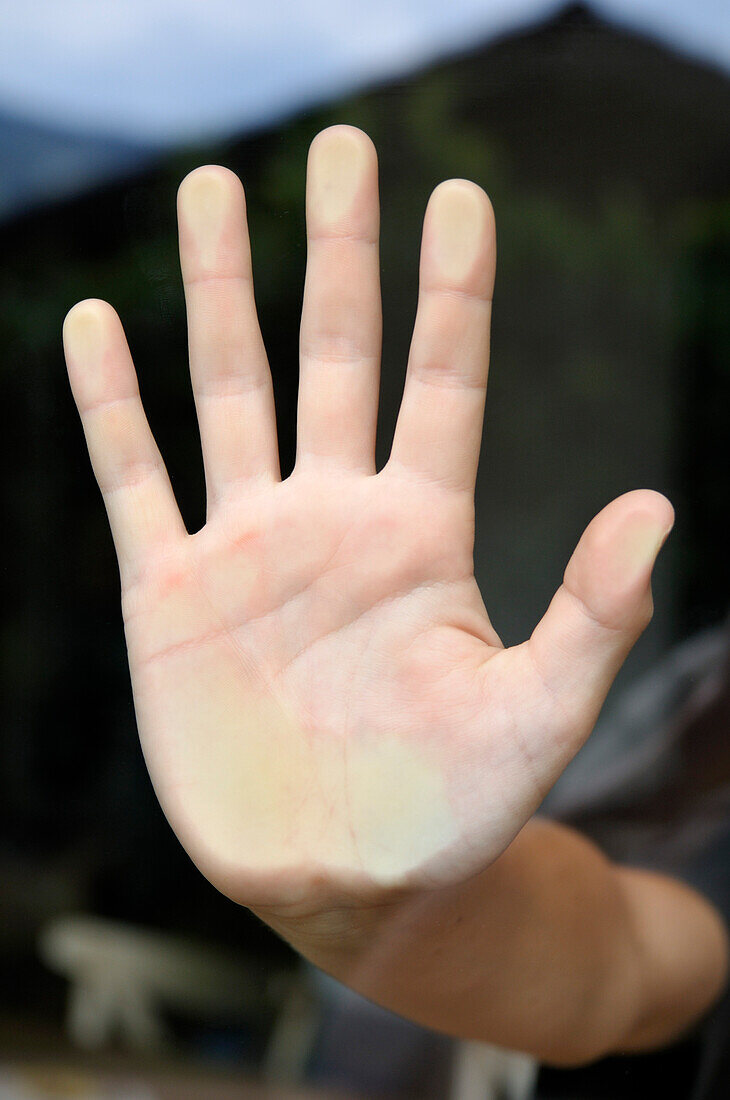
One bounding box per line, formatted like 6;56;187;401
64;299;186;582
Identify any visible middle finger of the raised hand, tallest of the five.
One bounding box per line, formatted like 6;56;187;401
297;125;381;473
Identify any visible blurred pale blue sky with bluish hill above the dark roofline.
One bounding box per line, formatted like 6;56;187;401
0;0;730;218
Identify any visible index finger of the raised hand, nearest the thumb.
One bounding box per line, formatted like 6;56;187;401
388;179;496;492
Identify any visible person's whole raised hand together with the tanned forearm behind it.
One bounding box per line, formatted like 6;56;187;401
64;125;727;1062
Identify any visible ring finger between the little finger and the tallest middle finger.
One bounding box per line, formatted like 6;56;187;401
177;165;279;512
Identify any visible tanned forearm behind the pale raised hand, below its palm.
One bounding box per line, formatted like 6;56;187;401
253;820;727;1064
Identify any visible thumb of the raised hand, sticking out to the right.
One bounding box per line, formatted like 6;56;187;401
528;490;674;752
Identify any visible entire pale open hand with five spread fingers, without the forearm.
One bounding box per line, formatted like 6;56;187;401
66;128;671;910
